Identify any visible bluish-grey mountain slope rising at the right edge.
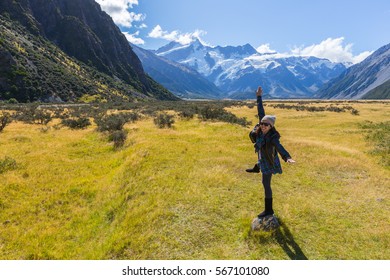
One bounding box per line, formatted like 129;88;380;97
316;44;390;99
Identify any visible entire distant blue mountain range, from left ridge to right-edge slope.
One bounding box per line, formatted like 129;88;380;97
136;40;390;99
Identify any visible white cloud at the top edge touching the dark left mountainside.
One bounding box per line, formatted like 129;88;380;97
95;0;146;28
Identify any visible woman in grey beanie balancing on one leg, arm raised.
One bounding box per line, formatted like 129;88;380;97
246;87;295;219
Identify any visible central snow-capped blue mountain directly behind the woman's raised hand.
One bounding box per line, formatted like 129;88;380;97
155;40;346;98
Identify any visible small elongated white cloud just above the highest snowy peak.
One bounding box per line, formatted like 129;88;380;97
148;25;206;45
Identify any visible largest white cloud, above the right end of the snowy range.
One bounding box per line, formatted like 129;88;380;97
291;37;372;64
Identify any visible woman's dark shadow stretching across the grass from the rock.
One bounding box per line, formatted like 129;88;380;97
272;218;308;260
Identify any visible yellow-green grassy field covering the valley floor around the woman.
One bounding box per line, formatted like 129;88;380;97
0;101;390;260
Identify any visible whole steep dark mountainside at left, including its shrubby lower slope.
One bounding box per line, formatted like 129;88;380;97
0;0;176;101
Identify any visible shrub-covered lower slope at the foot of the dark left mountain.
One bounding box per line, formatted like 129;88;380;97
0;12;173;102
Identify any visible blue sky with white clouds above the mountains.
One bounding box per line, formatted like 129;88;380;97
96;0;390;63
